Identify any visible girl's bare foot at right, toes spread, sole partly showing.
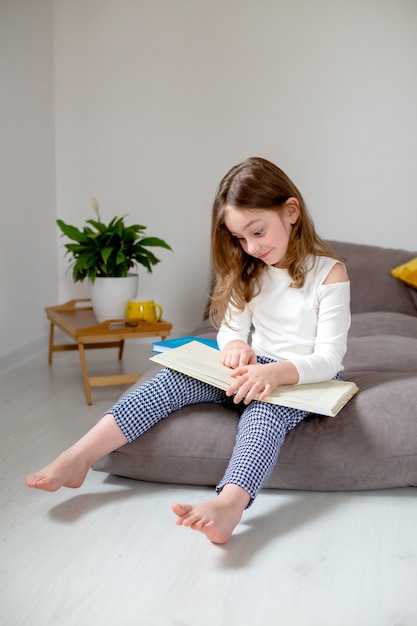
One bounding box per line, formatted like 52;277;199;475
172;485;249;544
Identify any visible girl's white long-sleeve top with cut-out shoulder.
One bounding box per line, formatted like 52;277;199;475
217;256;350;384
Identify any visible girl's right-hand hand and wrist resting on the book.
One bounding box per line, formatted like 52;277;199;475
226;361;298;404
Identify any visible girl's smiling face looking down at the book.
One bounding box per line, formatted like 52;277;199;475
224;198;300;267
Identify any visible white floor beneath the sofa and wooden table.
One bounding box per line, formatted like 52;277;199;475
0;345;417;626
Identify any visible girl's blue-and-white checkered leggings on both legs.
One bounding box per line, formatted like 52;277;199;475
107;357;308;506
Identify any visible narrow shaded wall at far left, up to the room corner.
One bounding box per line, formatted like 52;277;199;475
0;0;58;369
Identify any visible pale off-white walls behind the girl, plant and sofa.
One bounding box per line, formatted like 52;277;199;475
0;0;417;368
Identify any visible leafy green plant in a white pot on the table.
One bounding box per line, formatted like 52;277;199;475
56;198;171;322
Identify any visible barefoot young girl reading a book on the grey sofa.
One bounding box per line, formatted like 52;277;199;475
26;158;350;543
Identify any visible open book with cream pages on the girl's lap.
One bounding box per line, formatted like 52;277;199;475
151;341;358;417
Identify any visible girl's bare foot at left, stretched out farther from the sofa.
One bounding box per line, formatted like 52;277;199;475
26;451;90;491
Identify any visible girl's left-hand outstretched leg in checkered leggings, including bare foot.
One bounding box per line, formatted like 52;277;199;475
26;369;224;491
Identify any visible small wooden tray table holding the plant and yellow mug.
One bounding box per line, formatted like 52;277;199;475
45;299;172;404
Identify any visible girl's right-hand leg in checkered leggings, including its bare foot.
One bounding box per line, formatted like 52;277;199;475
173;401;308;543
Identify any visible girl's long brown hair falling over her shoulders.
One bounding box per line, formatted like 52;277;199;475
209;157;342;327
